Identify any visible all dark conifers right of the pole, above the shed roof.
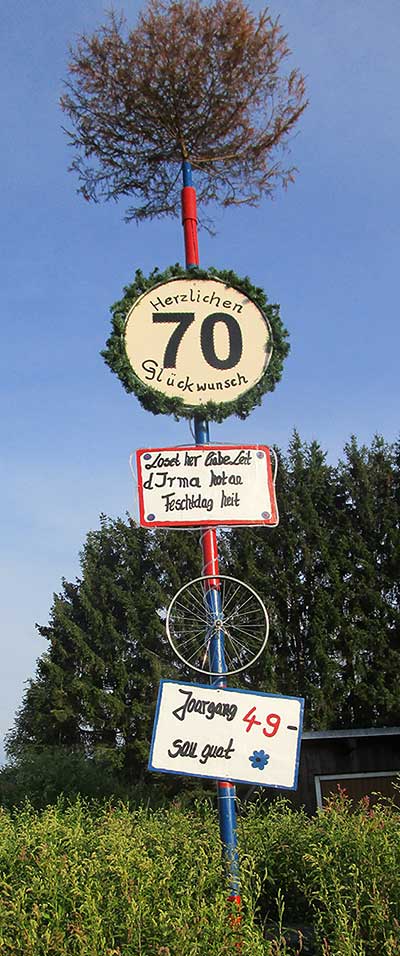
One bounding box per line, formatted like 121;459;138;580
225;432;400;730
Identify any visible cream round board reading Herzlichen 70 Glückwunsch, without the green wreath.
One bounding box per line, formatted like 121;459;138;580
125;277;272;407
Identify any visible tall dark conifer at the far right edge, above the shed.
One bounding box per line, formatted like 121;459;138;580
336;436;400;727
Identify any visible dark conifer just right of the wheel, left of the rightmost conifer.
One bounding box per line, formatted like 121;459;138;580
227;432;337;727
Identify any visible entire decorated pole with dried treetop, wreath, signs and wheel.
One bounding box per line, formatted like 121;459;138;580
62;0;307;948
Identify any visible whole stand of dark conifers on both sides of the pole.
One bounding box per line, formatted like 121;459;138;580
0;433;400;792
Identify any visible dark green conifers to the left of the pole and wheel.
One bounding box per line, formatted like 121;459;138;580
8;516;200;781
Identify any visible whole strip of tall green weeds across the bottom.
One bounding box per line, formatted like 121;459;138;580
0;796;400;956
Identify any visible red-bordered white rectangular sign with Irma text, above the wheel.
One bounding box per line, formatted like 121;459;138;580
136;445;279;528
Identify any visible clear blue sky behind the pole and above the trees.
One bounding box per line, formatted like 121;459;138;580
0;0;400;756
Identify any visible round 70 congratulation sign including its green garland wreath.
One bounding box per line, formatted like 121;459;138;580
101;263;289;422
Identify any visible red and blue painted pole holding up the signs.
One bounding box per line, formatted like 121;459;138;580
182;160;241;906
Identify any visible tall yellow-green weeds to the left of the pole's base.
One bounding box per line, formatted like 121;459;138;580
0;801;263;956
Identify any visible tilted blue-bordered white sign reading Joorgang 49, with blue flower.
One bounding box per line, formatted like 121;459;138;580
149;680;304;790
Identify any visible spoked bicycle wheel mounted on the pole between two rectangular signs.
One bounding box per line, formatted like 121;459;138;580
165;574;269;676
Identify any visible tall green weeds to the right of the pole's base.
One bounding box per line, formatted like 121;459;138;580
244;792;400;956
